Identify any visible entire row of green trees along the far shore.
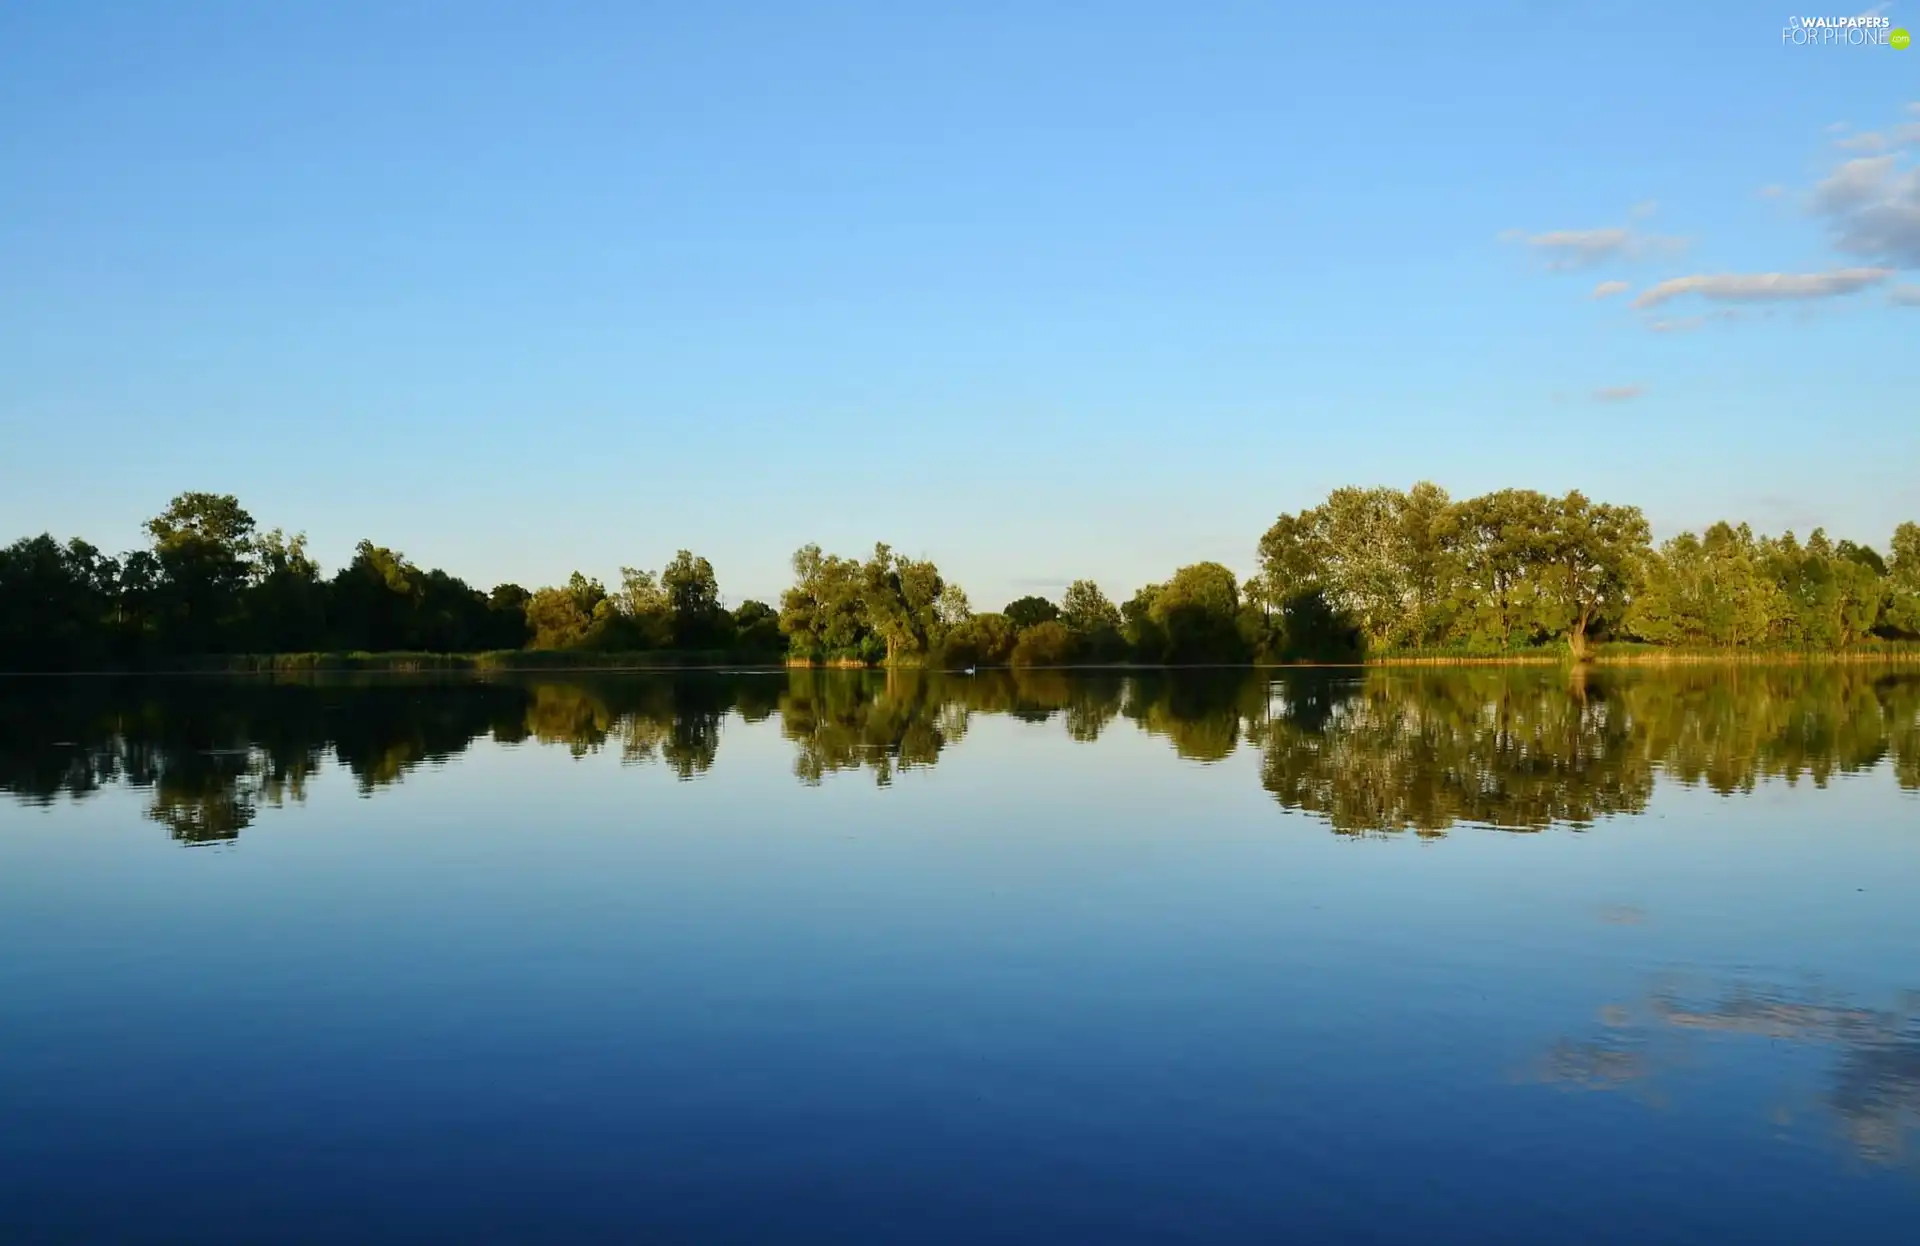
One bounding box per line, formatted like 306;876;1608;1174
0;484;1920;670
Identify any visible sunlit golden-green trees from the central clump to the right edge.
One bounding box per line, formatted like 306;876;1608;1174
780;484;1920;666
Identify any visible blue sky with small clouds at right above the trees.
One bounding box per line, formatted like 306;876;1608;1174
0;0;1920;609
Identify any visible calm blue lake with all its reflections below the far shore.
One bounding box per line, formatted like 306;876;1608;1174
0;664;1920;1246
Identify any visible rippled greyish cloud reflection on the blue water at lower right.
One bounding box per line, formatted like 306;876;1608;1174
1530;983;1920;1169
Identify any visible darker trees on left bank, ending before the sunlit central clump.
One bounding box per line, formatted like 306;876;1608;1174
0;493;785;670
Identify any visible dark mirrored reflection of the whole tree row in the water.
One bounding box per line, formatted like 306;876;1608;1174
0;666;1920;843
